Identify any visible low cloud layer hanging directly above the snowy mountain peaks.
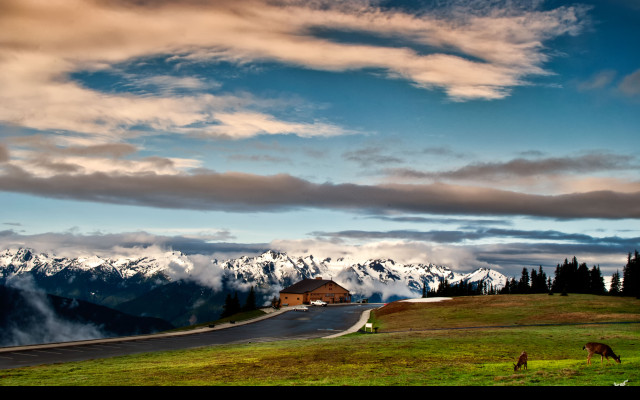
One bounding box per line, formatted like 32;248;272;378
0;228;639;278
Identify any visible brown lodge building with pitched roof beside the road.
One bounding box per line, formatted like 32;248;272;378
280;277;351;306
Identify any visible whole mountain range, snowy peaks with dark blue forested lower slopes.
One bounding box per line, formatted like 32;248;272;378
0;248;506;332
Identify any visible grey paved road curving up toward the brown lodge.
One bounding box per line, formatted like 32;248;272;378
0;304;380;369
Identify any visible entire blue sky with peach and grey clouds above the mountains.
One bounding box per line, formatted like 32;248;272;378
0;0;640;276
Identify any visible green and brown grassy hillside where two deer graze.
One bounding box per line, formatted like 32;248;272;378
0;294;640;386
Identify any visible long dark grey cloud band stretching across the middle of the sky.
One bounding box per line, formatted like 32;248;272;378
0;167;640;219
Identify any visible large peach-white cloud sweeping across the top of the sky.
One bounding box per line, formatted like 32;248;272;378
0;0;584;137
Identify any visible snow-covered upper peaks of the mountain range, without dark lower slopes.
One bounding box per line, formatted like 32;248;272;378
0;248;506;299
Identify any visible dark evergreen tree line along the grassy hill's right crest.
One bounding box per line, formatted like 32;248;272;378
422;250;640;298
